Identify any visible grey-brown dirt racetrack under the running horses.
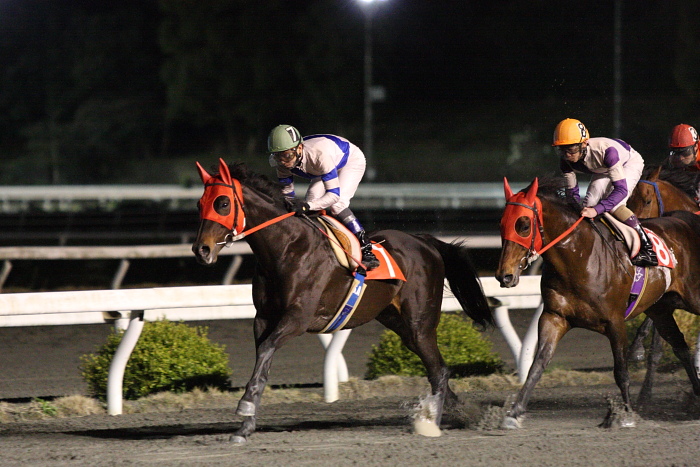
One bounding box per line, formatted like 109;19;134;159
0;313;700;466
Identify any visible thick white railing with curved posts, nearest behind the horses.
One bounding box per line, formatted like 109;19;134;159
0;276;539;415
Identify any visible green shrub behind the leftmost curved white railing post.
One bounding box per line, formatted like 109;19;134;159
81;320;230;400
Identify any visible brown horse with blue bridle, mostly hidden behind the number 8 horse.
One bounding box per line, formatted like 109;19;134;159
627;166;700;405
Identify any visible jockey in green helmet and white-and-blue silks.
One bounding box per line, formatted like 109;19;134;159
267;125;379;270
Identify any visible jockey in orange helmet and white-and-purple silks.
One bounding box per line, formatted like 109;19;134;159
552;118;658;266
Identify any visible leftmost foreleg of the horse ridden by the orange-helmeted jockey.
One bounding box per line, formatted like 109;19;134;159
501;312;570;429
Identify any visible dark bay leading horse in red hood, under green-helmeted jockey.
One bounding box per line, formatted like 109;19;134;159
192;159;494;443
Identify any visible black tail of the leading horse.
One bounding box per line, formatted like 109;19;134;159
419;234;495;328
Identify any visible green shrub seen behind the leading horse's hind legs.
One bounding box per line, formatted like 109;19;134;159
365;314;503;379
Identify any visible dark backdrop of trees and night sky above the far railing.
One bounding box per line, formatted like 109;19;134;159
0;0;700;184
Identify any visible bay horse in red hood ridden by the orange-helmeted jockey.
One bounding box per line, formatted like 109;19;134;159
496;179;700;428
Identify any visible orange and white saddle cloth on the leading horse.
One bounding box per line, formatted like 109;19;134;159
318;214;406;282
